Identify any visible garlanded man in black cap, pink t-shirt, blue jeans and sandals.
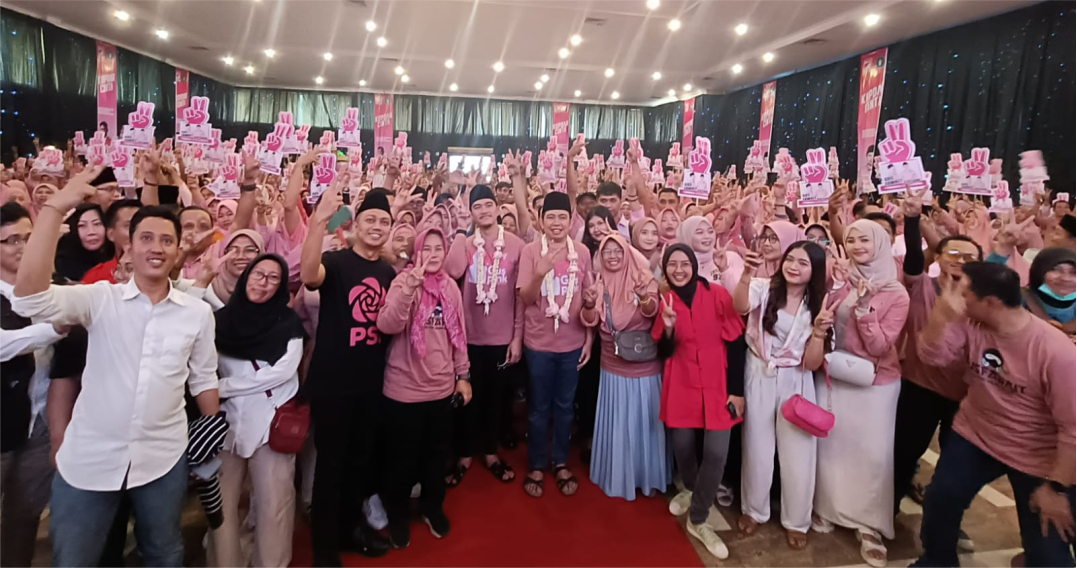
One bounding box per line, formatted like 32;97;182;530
516;192;595;497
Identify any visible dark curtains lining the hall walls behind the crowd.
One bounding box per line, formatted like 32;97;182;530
0;2;1077;192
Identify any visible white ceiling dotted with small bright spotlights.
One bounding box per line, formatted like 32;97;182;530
4;0;1034;105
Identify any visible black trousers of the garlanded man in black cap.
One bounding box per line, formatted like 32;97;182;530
452;345;509;458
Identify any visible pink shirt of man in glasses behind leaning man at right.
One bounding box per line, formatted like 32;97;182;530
901;273;968;401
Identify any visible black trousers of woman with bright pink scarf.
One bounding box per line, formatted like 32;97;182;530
383;397;453;526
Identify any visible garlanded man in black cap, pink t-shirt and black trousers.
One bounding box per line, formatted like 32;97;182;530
445;184;523;487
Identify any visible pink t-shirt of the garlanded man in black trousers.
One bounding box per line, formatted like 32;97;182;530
445;227;523;345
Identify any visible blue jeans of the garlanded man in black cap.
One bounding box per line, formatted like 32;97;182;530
523;348;582;469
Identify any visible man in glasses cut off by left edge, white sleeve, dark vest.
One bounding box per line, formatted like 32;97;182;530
0;202;64;566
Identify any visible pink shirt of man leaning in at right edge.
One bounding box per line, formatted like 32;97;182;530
919;316;1077;482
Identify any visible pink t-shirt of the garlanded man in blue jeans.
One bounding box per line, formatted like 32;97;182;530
516;238;592;354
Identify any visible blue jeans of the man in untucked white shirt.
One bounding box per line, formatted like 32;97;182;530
48;456;187;566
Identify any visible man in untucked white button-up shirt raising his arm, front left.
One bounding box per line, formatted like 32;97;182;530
12;168;220;566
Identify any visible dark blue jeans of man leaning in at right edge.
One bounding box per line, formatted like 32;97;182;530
912;430;1074;568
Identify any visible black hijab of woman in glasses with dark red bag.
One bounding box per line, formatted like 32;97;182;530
216;254;306;364
